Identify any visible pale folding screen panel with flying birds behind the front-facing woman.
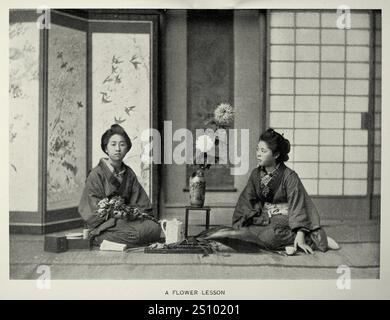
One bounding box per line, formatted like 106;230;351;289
90;20;154;197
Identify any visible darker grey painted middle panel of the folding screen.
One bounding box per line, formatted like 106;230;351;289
47;18;87;211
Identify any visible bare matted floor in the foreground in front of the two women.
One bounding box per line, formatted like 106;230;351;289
10;220;380;279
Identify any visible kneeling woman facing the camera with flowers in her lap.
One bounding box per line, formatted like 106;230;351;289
79;124;161;247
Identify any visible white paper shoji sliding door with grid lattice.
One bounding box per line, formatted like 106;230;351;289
268;10;380;218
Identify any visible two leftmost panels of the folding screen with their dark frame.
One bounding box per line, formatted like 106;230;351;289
9;10;87;233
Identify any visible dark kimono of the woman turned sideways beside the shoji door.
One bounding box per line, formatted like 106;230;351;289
232;163;327;251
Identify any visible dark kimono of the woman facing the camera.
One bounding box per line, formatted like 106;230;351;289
79;159;161;246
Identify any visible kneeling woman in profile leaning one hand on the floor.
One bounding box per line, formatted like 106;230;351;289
229;129;338;253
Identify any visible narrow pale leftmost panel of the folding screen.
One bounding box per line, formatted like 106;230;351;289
9;13;40;214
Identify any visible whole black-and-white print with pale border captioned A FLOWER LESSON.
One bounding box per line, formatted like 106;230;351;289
2;1;390;299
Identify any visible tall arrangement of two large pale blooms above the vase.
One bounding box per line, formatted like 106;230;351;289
194;103;234;170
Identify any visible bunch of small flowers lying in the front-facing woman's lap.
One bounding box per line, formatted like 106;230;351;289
97;196;157;222
